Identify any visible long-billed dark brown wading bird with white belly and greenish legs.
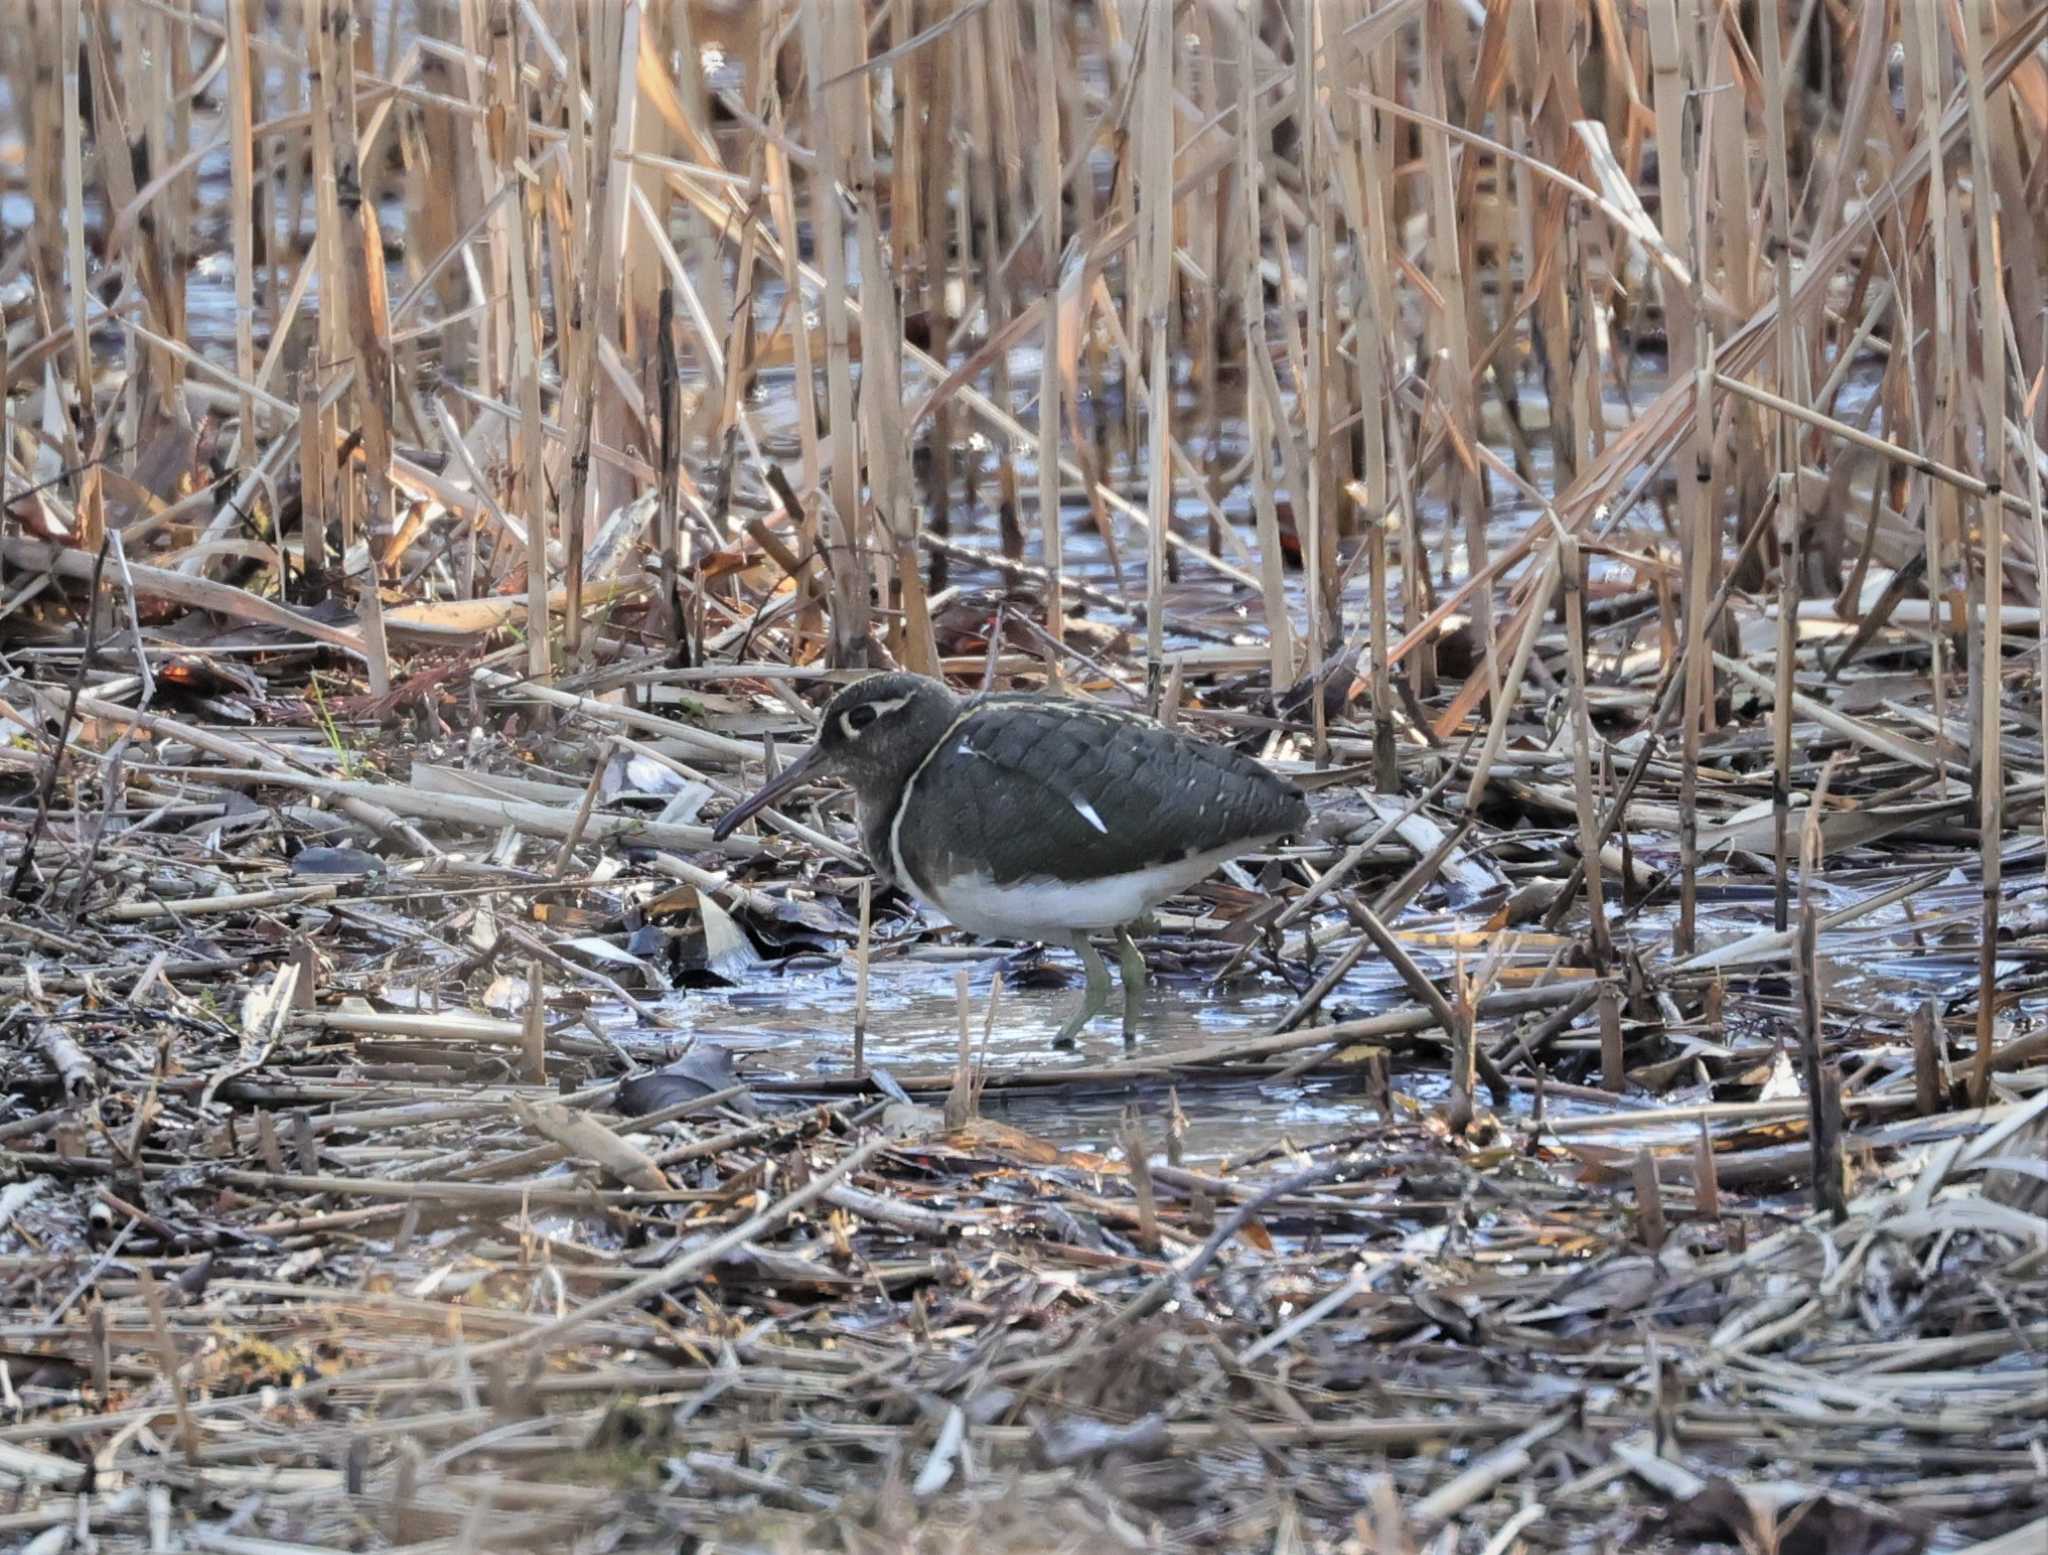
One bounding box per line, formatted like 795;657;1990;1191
711;672;1309;1047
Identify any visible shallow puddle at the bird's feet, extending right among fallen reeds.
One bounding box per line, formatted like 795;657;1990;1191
643;863;2015;1162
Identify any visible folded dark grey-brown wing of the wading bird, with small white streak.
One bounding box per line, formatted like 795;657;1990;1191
903;697;1309;885
